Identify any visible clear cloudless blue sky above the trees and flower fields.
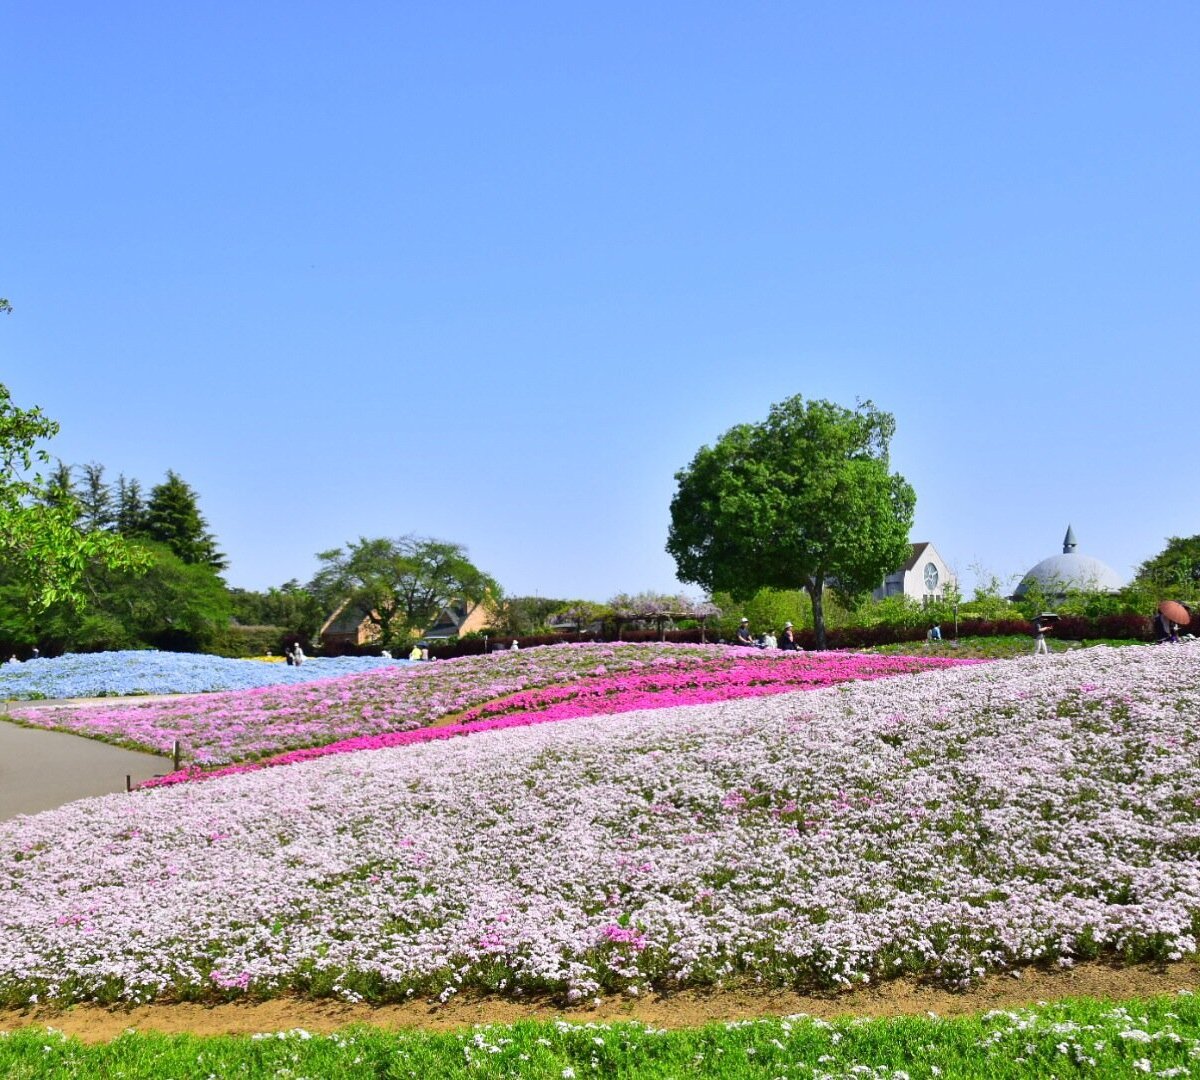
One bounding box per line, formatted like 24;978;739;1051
0;0;1200;600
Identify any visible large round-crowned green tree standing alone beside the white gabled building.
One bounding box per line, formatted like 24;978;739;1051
667;395;917;648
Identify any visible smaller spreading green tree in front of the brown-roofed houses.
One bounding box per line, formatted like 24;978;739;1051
310;535;499;648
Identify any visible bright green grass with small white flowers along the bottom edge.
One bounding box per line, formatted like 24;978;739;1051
0;994;1200;1080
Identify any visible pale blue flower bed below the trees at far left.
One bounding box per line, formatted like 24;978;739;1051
0;649;415;701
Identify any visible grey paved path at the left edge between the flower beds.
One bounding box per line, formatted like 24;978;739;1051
0;698;172;821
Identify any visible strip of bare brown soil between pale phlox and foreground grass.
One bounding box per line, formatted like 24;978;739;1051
0;960;1200;1043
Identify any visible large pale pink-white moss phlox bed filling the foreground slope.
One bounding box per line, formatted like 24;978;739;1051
0;644;1200;1003
